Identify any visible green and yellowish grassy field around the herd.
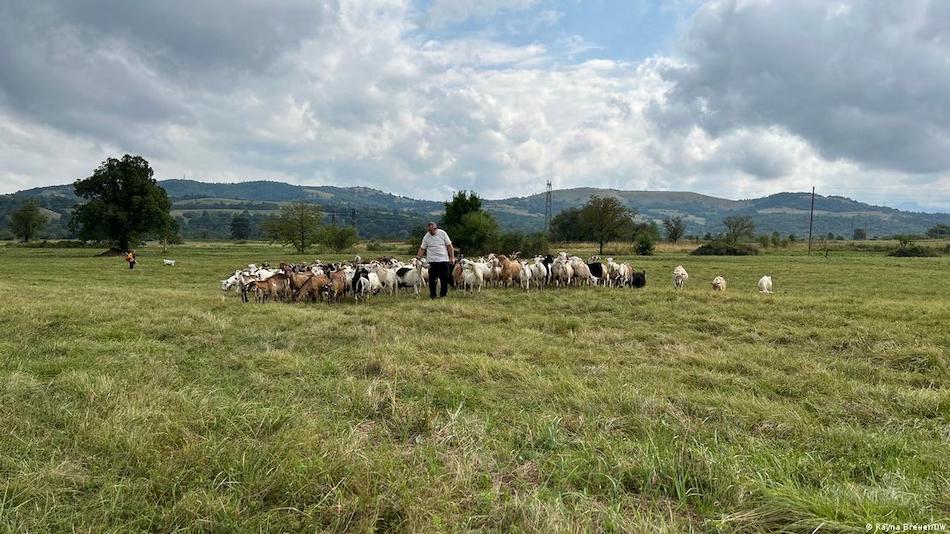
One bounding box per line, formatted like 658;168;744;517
0;244;950;532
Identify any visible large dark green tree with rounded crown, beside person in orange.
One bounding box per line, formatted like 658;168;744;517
69;154;173;251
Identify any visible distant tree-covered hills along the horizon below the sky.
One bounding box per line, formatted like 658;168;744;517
0;180;950;239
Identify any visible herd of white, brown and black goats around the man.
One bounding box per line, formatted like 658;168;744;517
221;252;772;302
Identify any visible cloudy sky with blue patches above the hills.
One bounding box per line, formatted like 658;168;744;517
0;0;950;211
